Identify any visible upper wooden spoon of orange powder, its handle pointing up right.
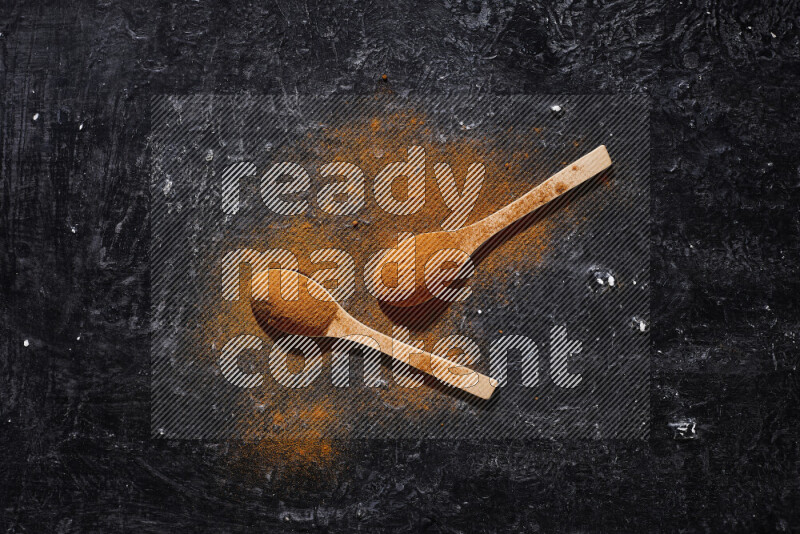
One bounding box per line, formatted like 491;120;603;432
371;145;611;307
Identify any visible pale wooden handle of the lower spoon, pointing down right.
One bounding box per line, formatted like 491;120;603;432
328;314;497;400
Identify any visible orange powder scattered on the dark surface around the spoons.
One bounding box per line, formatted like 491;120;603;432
197;101;592;478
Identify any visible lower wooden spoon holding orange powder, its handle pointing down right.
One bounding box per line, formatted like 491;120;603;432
250;269;497;399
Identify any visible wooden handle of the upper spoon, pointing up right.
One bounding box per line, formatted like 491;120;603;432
462;145;611;248
